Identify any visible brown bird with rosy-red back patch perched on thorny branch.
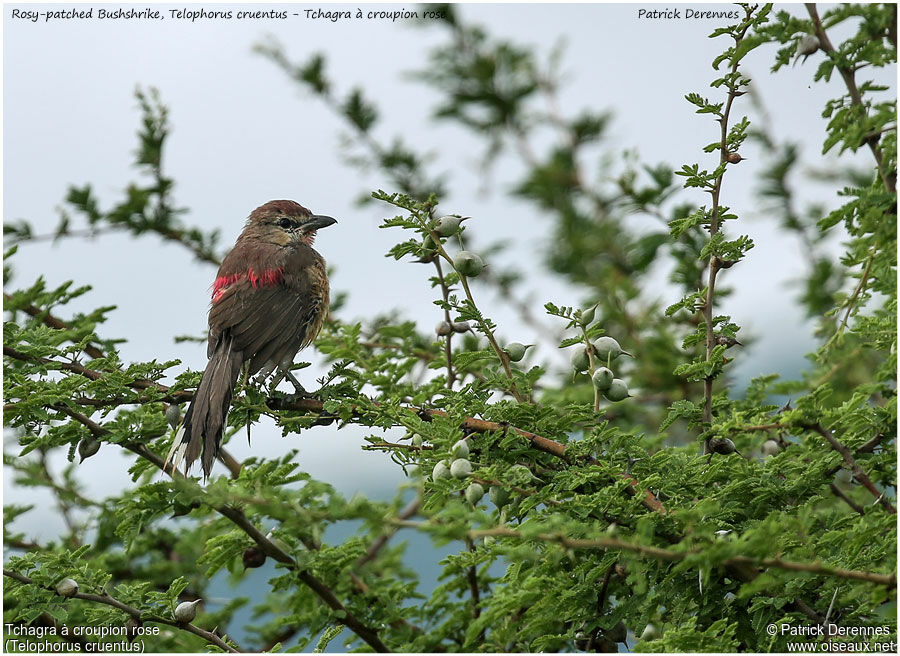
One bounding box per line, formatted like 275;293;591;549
163;200;337;480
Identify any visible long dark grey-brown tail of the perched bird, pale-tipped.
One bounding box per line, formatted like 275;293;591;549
163;339;243;477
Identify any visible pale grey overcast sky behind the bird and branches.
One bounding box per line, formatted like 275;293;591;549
3;3;892;535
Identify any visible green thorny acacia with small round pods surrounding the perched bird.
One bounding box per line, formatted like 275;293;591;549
4;5;897;652
